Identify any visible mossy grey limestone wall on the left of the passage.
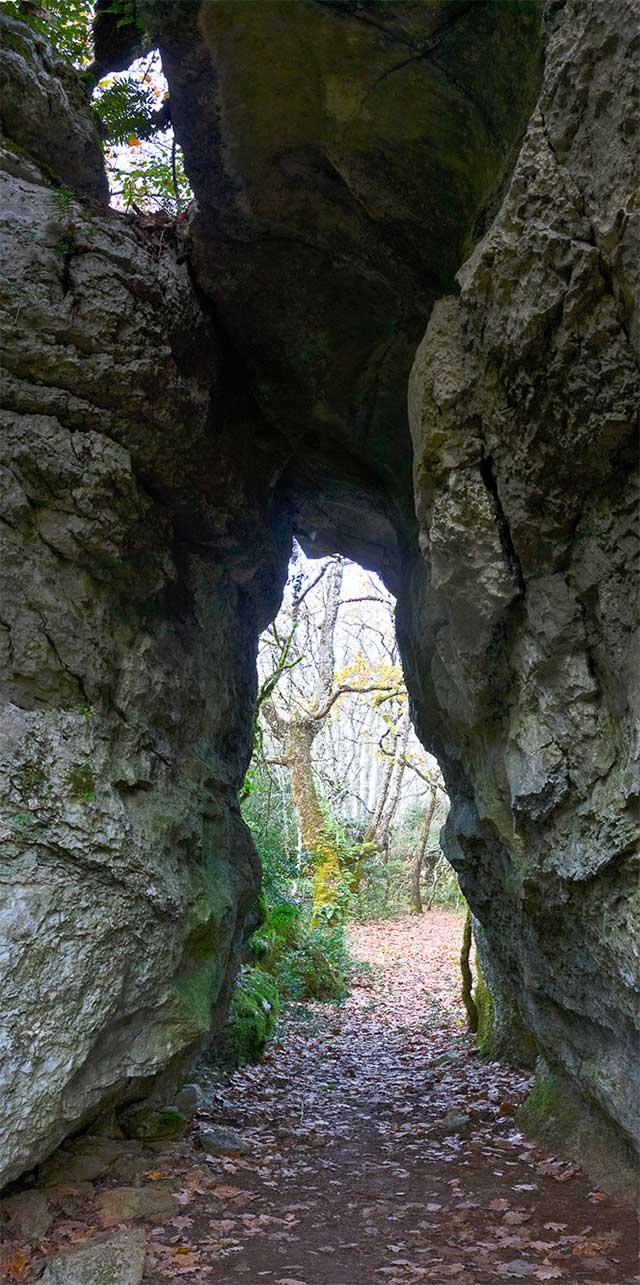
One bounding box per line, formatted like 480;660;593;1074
0;127;287;1185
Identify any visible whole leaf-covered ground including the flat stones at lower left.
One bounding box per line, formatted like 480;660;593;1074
0;911;640;1285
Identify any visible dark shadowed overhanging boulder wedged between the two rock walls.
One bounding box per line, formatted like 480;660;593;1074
147;0;541;564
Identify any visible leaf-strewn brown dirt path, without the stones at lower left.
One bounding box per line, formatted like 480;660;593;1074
148;912;636;1285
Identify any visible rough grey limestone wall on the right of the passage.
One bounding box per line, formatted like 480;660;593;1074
405;0;640;1166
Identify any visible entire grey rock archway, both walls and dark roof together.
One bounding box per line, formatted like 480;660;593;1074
0;0;639;1182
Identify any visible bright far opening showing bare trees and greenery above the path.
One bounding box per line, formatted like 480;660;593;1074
240;541;454;925
